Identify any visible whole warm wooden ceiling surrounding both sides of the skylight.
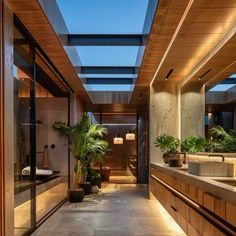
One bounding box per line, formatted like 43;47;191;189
8;0;236;111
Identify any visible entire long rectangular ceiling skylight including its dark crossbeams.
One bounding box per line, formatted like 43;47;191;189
51;0;157;103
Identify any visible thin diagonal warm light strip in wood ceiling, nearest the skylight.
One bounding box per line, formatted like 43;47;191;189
151;0;194;85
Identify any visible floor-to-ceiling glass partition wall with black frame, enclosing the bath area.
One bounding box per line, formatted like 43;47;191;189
13;20;69;235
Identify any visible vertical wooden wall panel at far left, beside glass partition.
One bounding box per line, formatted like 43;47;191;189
3;0;14;236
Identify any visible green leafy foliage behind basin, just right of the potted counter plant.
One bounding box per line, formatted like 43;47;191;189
181;136;206;153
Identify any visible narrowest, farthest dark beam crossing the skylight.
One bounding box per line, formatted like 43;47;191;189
86;78;135;84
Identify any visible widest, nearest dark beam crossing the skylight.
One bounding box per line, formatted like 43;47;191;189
67;34;147;46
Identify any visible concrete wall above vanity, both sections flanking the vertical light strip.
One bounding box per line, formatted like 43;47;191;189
149;83;205;163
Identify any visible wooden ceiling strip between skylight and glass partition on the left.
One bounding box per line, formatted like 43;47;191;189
8;0;90;103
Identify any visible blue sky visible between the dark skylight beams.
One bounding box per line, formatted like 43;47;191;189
56;0;149;91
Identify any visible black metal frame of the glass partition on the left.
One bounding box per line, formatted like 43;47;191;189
14;16;73;235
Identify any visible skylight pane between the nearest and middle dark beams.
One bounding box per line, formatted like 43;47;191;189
76;46;138;66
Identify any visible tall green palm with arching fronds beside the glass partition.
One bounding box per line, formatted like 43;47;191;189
53;114;108;189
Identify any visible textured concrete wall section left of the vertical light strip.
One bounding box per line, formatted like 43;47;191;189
149;84;180;163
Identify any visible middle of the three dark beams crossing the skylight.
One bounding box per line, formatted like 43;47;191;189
75;66;138;74
